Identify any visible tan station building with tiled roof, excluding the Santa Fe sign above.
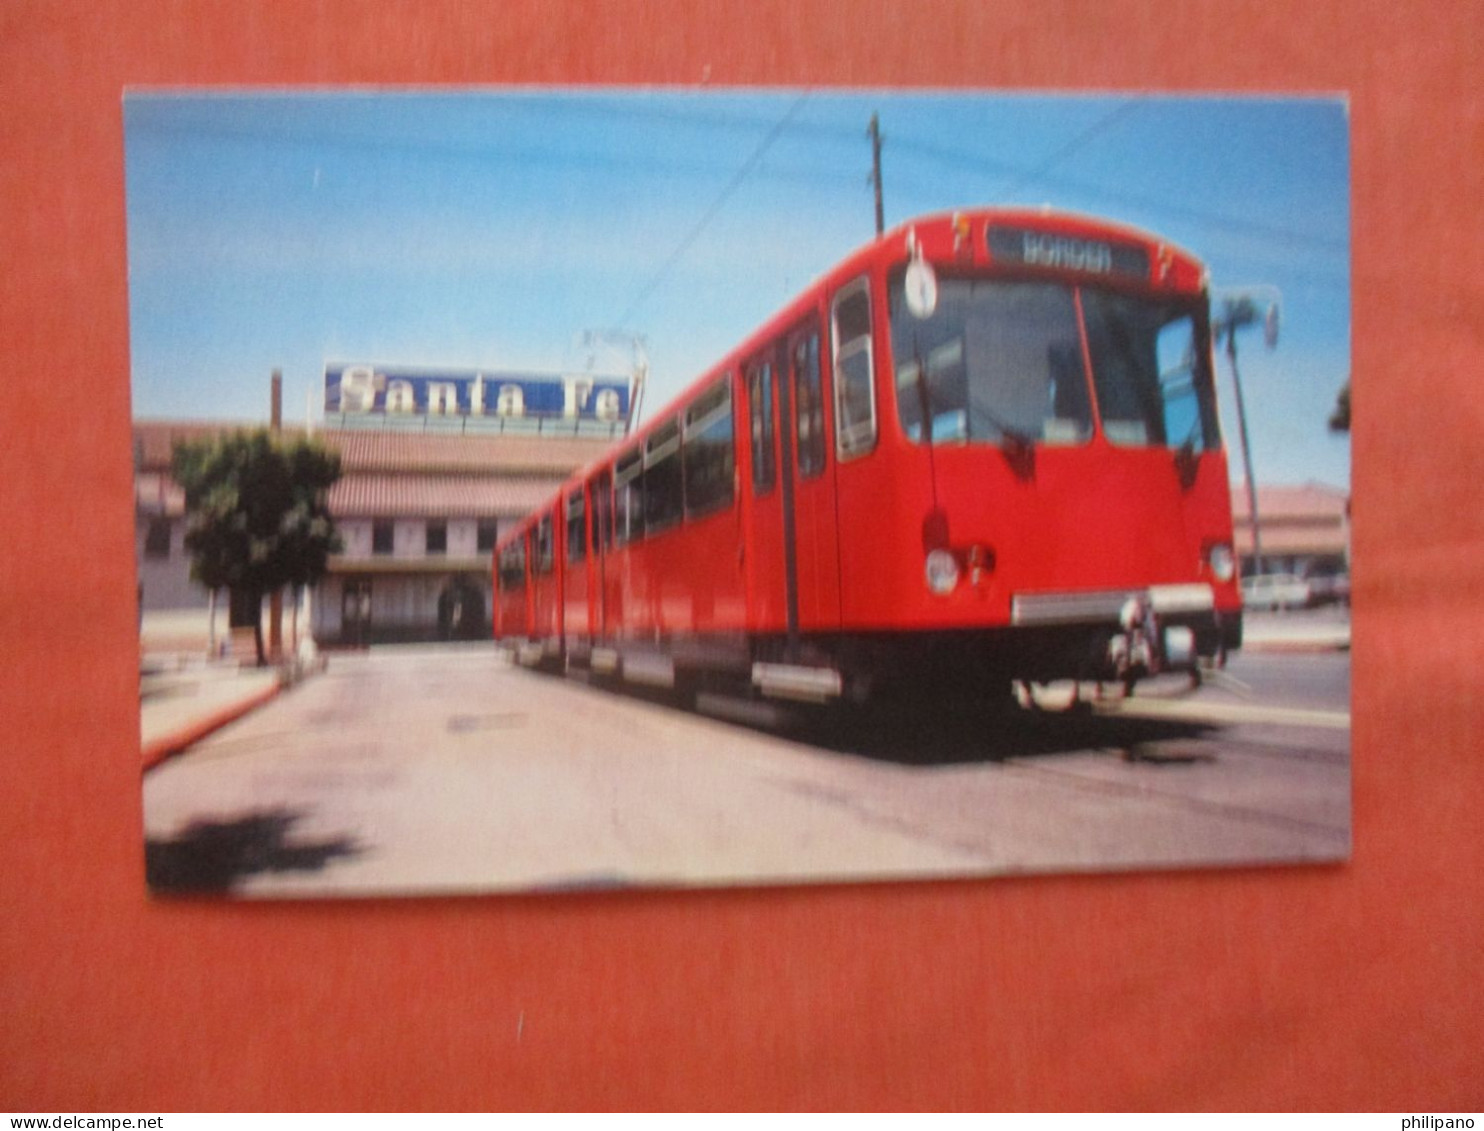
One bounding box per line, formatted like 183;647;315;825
134;422;608;644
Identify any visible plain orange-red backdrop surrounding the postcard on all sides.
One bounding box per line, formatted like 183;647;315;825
0;0;1484;1112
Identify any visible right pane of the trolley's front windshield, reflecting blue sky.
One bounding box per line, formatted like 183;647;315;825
1082;289;1220;451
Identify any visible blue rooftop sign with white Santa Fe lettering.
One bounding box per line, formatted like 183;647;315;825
325;364;631;422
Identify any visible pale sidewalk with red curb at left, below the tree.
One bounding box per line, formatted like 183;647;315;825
139;653;283;769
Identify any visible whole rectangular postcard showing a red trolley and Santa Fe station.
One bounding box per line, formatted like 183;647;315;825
123;88;1350;898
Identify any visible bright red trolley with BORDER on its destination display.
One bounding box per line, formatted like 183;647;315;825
494;209;1242;701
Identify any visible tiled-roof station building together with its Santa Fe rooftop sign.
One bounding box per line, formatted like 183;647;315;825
134;367;628;649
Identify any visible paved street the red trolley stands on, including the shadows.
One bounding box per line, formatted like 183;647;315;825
144;620;1349;895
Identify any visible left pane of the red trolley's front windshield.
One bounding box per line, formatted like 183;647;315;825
889;272;1092;444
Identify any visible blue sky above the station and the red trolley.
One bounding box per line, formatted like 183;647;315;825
125;89;1350;487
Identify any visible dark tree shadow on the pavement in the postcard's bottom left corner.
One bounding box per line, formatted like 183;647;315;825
144;809;362;895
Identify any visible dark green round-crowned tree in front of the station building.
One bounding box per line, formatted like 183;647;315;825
171;429;341;665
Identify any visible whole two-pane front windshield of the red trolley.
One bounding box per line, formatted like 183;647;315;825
890;272;1220;451
